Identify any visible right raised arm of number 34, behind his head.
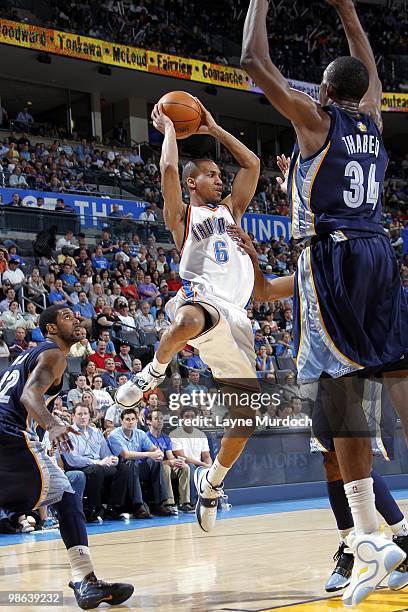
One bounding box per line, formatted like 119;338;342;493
326;0;382;131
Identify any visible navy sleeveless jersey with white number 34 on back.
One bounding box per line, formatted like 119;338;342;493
288;105;388;240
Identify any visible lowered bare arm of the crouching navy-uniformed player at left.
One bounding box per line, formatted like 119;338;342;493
21;350;77;450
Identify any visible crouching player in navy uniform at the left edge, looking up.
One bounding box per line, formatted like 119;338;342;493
0;306;133;610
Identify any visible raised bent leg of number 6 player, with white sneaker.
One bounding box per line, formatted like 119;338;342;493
115;304;206;408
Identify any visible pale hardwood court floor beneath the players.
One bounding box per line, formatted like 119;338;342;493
0;500;408;612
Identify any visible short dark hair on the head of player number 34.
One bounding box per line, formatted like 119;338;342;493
326;56;370;101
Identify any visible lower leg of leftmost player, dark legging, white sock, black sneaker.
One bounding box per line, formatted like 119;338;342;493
54;491;134;610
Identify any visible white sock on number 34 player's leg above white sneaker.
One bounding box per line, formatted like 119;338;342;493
344;477;379;535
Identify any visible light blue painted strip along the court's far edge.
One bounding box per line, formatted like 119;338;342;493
0;489;408;547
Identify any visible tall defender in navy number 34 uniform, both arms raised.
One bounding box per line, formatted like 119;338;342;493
241;0;408;606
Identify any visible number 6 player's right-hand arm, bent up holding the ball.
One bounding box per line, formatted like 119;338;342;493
197;100;260;223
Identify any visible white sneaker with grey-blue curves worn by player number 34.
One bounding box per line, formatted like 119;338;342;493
342;533;406;608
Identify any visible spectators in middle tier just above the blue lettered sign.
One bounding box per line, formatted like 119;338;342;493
0;132;408;227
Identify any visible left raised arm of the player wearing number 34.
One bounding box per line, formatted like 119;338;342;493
241;0;327;132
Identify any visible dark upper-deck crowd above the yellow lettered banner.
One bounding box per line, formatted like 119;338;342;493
14;0;408;90
